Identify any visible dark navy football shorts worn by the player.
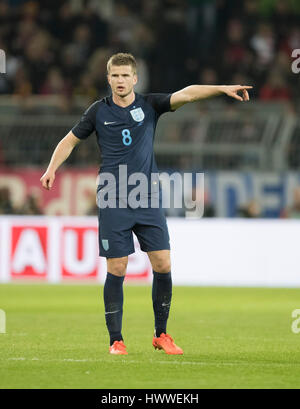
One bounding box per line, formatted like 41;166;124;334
98;199;170;258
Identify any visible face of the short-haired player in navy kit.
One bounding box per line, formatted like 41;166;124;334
107;65;137;98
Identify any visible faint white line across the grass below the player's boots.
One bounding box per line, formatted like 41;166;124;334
0;357;300;368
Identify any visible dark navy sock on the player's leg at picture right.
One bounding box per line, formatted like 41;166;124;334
152;271;172;337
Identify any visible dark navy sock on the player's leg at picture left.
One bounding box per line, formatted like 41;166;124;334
103;273;125;345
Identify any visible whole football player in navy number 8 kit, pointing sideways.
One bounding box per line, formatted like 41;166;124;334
41;53;252;355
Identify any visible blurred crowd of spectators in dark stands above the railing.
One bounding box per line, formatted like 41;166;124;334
0;0;300;111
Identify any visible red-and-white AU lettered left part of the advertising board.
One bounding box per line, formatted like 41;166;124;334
0;216;152;283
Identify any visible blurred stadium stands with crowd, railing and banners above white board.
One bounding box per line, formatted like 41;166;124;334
0;0;300;217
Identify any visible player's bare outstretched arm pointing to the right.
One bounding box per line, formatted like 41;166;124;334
170;85;253;111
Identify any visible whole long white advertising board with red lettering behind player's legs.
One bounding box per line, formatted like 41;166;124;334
0;215;300;288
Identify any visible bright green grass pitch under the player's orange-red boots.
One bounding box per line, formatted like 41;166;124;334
0;283;300;389
